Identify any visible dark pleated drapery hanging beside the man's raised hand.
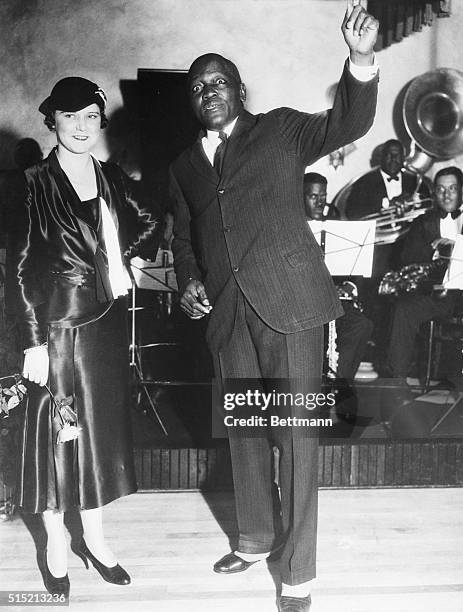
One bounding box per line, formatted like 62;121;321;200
368;0;450;51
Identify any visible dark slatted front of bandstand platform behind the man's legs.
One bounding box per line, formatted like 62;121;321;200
135;440;463;491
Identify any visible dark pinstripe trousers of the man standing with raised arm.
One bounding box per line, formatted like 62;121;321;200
213;285;323;585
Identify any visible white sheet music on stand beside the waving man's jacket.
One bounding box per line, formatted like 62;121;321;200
308;220;376;277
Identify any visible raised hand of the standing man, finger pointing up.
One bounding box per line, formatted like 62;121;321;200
341;0;379;66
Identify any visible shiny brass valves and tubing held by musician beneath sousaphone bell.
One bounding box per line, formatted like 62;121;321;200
362;193;432;244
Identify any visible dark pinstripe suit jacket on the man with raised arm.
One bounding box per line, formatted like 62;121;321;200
170;62;377;344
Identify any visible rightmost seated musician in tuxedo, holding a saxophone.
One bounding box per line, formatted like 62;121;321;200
388;166;463;380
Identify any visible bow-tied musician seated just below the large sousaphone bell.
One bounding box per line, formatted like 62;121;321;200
345;139;430;220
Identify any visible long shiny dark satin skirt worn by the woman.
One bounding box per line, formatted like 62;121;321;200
16;298;137;513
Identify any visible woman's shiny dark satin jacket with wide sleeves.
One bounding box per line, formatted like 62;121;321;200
15;150;157;348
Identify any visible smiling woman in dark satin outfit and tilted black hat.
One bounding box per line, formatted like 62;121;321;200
16;77;157;596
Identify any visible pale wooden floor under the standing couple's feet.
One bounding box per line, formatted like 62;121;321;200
0;488;463;612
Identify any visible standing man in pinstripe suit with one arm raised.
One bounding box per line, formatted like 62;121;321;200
170;6;378;611
